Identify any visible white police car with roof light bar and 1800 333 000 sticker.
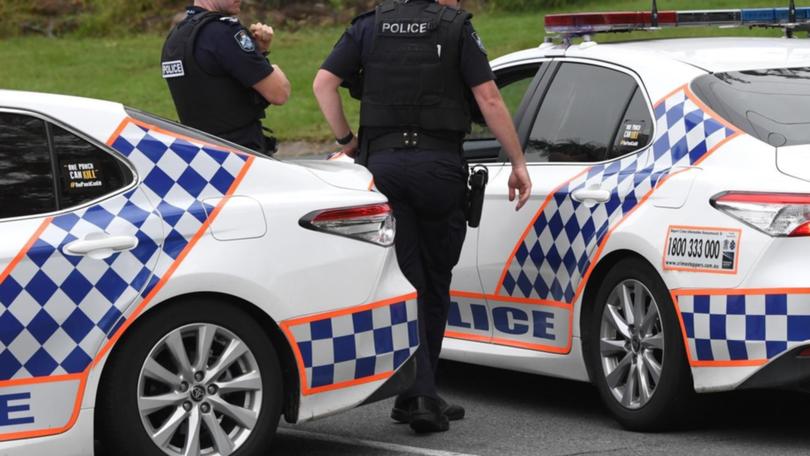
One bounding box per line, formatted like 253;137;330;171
443;4;810;430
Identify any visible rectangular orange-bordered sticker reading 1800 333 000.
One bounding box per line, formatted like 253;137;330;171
664;226;742;274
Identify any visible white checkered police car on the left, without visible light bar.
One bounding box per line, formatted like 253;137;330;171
0;91;418;456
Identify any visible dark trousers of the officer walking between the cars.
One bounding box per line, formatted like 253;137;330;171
368;149;467;401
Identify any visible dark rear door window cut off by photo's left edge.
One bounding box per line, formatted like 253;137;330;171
0;112;56;219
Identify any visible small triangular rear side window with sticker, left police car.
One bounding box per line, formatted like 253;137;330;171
51;125;133;208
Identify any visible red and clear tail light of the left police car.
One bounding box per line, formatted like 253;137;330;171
299;204;396;247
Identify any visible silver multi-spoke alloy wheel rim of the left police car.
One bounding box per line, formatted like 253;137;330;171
137;323;262;456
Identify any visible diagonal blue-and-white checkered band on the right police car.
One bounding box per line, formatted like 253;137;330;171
502;90;736;303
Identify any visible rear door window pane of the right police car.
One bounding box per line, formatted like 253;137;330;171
526;62;649;163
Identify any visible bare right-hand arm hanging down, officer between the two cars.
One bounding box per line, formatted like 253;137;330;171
472;81;532;209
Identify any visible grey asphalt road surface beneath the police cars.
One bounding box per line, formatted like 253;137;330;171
273;362;810;456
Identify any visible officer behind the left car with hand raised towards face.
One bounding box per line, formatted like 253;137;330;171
161;0;290;152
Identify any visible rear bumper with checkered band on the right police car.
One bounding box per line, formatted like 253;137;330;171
672;238;810;391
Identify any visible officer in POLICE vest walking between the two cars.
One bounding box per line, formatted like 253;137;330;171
313;0;531;433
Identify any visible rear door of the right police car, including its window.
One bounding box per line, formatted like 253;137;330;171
479;59;652;353
